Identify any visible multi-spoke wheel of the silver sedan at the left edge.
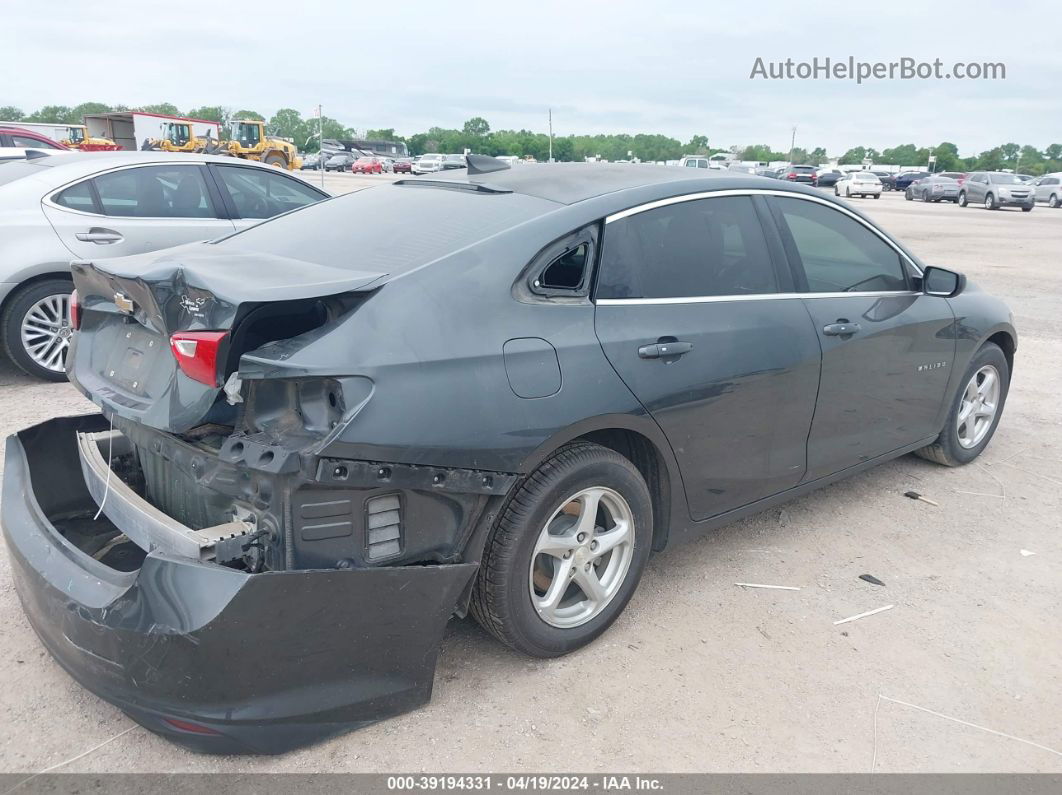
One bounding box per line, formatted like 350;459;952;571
0;279;73;381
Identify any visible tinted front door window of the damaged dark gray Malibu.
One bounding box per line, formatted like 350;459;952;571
771;198;908;293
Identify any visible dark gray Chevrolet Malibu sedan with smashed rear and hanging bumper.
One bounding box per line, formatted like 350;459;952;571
2;156;1016;753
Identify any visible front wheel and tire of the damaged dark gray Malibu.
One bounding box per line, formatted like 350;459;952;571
914;343;1010;467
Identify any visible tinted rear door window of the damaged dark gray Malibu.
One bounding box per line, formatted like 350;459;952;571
597;196;778;298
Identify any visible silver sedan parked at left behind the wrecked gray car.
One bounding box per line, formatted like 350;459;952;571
0;152;328;381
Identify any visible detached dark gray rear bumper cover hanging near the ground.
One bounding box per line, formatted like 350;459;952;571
0;415;476;754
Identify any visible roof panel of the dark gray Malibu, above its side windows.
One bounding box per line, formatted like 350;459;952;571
418;162;788;205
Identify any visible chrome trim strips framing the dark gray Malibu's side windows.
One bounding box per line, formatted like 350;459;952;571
594;188;922;307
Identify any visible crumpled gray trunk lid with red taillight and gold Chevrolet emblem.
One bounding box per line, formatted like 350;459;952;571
69;243;387;433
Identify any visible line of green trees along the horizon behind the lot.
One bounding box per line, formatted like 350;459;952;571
0;102;1062;175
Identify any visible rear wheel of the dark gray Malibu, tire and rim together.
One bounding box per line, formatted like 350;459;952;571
470;442;653;657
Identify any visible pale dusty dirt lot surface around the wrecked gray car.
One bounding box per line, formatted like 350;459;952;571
0;182;1062;773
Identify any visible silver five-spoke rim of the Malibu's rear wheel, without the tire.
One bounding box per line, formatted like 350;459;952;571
529;486;635;628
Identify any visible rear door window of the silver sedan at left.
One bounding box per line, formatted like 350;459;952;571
93;166;216;218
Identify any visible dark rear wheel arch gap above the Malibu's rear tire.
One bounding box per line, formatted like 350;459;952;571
520;414;686;552
